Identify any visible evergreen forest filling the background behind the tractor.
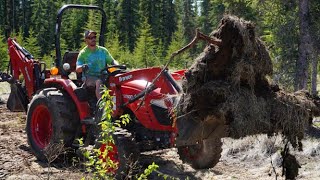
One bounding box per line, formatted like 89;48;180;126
0;0;320;94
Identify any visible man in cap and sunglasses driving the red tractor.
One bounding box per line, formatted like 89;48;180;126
76;30;119;99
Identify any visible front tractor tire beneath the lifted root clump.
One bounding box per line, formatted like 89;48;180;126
178;126;225;169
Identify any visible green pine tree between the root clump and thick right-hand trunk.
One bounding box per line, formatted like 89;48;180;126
257;0;298;90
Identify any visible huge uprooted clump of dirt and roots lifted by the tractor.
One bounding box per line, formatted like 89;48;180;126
177;16;319;148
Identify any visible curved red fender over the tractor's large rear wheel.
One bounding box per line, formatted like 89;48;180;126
44;78;90;120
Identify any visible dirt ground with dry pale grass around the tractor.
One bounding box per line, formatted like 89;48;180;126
0;83;320;180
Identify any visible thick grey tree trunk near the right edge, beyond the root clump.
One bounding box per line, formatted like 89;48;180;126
295;0;310;91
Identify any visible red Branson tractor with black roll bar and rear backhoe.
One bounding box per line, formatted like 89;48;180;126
1;5;184;176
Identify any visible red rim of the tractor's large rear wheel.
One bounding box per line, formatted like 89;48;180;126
31;105;52;149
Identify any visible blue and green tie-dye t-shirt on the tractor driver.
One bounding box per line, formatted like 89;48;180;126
77;46;113;77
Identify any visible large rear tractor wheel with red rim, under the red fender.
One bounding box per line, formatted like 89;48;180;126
26;88;80;162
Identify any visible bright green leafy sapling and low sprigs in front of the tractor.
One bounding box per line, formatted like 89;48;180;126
78;87;174;180
